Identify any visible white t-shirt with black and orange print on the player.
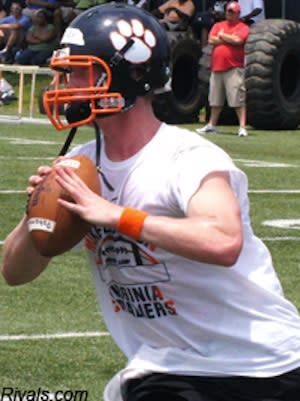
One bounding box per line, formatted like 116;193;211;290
68;124;300;377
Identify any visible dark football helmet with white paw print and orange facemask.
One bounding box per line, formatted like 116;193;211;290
44;3;171;130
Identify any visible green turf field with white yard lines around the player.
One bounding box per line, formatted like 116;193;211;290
0;124;300;401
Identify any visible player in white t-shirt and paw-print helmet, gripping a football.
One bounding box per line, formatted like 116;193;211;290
2;3;300;401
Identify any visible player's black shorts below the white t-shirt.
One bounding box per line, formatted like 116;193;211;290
123;368;300;401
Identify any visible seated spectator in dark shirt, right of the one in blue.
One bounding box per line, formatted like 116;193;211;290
15;9;59;66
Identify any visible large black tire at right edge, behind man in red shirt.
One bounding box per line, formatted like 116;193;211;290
245;19;300;130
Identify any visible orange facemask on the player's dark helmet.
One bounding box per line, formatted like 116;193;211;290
43;55;124;130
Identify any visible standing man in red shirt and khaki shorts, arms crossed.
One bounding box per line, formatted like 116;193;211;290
196;1;249;136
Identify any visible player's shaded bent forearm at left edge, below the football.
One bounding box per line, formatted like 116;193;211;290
2;217;49;285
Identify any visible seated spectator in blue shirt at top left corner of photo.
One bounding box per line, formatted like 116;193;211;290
0;1;31;62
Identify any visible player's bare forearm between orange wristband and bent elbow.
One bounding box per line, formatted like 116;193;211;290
141;216;243;267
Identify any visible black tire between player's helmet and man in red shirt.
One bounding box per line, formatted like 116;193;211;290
153;32;207;124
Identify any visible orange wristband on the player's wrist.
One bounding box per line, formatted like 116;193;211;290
117;207;148;239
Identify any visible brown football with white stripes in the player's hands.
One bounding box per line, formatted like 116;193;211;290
28;155;100;257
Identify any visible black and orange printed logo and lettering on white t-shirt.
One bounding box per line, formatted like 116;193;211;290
85;227;177;319
